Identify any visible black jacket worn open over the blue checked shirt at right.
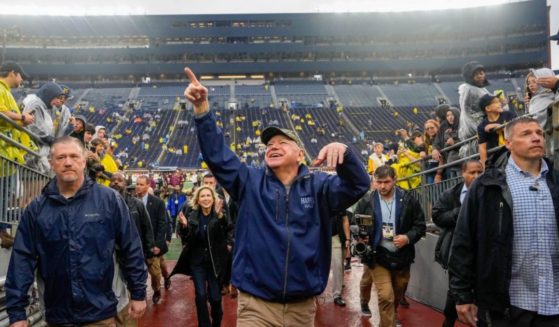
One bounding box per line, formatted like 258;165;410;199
449;149;559;312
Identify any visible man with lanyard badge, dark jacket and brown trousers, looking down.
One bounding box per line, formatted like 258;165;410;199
355;166;425;327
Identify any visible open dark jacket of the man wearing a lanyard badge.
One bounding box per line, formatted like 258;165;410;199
354;187;426;266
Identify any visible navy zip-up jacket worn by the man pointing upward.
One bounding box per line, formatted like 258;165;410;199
196;112;369;303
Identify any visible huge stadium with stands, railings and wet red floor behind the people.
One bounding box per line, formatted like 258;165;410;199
0;0;559;327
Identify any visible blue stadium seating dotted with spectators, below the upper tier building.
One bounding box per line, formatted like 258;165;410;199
9;77;523;168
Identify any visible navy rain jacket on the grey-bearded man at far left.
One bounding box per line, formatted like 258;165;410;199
6;178;147;324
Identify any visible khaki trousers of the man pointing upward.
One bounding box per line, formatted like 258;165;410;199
237;291;317;327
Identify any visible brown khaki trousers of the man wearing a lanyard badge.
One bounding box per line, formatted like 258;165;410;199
369;265;410;327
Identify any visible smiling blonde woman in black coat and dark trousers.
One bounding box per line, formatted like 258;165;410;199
171;186;230;327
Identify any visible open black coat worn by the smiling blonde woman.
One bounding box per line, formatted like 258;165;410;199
171;210;232;282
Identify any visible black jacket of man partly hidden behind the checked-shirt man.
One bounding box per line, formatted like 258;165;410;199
432;182;464;269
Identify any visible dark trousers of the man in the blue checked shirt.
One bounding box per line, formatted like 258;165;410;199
478;307;559;327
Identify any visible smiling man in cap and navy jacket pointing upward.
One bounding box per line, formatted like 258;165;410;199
185;68;369;326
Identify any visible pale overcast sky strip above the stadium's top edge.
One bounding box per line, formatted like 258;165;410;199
0;0;559;70
